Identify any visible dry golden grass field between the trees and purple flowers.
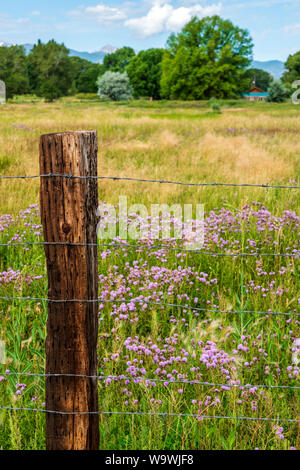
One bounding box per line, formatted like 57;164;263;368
0;102;300;213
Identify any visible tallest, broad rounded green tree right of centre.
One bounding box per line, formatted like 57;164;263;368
161;16;253;100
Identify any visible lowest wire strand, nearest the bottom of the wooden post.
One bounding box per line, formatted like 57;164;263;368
0;406;300;423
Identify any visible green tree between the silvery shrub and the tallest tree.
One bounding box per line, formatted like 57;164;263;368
126;49;163;99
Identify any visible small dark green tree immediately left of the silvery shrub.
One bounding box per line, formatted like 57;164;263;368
70;57;104;93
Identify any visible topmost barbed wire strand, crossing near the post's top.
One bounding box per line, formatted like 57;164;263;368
0;173;300;189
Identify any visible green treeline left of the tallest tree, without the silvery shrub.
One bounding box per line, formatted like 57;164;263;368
0;40;163;101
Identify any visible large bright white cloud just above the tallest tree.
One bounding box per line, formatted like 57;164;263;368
125;0;222;38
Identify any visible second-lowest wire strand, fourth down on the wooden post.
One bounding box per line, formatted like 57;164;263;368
0;372;300;390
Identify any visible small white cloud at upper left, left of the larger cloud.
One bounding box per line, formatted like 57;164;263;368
69;3;127;23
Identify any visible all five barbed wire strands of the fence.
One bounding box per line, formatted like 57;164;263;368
0;173;300;436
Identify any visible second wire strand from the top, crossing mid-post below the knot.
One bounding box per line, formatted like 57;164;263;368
0;242;300;258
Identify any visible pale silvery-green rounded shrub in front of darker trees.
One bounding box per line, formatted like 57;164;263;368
97;72;132;101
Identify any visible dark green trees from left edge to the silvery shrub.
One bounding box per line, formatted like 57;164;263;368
0;40;102;101
